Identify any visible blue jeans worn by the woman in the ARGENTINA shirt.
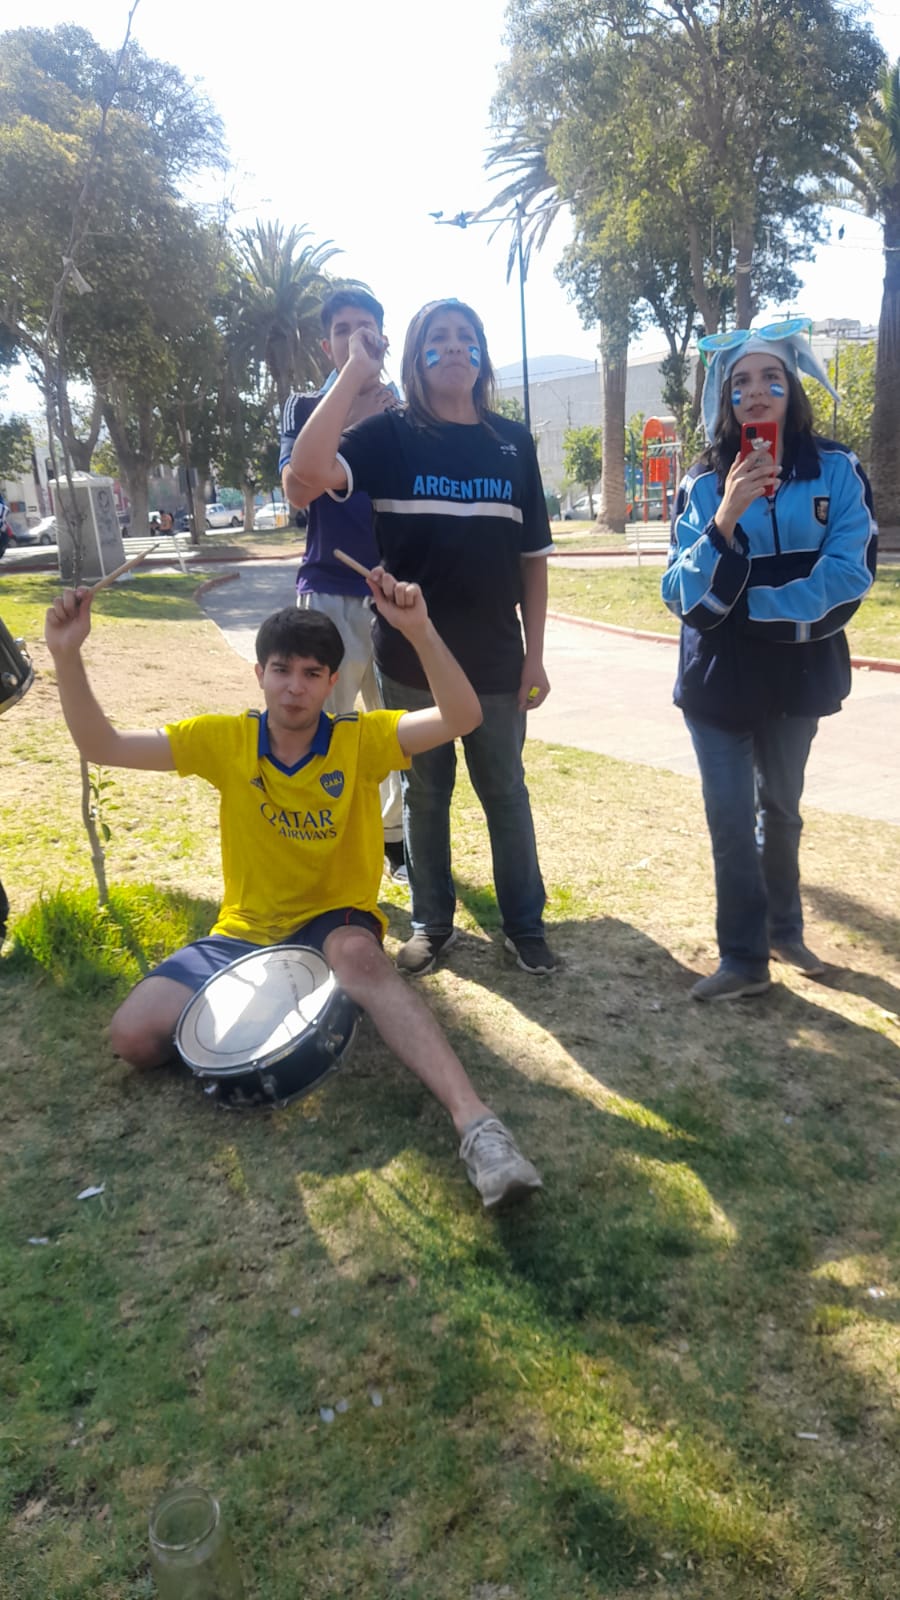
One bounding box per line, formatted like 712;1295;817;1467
378;672;546;939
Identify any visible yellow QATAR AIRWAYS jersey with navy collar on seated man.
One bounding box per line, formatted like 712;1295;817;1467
165;710;410;944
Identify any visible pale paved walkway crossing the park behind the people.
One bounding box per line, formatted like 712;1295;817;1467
202;562;900;826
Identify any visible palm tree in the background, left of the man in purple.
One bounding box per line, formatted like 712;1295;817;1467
230;222;340;408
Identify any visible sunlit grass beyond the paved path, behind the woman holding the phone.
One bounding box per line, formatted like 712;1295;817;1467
549;566;900;659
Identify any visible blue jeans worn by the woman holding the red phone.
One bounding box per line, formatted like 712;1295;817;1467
684;717;818;978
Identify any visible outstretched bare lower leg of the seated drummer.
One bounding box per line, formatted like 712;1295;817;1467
325;926;490;1133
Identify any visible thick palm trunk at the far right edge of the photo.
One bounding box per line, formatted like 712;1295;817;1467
870;208;900;528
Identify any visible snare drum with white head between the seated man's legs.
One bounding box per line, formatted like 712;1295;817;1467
175;944;360;1106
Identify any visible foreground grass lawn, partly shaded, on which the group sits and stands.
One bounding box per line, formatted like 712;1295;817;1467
0;573;900;1600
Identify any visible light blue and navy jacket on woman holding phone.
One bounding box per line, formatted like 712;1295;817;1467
663;435;878;726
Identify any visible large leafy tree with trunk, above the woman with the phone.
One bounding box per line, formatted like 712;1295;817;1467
490;0;881;526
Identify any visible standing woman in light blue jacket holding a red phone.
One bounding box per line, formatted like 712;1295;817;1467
663;317;878;1000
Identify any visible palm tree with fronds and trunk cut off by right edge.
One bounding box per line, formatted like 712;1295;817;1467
823;61;900;526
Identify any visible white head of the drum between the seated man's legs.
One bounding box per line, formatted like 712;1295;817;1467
176;944;335;1077
